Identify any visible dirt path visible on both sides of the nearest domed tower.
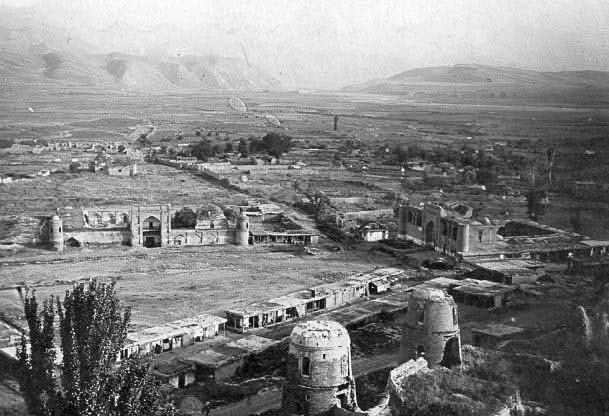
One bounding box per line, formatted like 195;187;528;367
209;354;398;416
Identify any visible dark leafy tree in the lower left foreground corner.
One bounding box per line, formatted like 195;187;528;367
18;280;177;416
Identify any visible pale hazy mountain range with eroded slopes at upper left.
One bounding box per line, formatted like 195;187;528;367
0;6;281;92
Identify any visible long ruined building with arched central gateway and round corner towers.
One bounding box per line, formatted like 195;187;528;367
44;204;318;251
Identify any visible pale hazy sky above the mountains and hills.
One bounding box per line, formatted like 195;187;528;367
0;0;609;87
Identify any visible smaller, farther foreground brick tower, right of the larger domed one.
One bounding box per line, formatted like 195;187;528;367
400;288;461;367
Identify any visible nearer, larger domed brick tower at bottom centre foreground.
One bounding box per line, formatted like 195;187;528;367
280;321;357;416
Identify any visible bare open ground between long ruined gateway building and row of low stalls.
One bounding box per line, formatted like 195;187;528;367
0;246;394;327
